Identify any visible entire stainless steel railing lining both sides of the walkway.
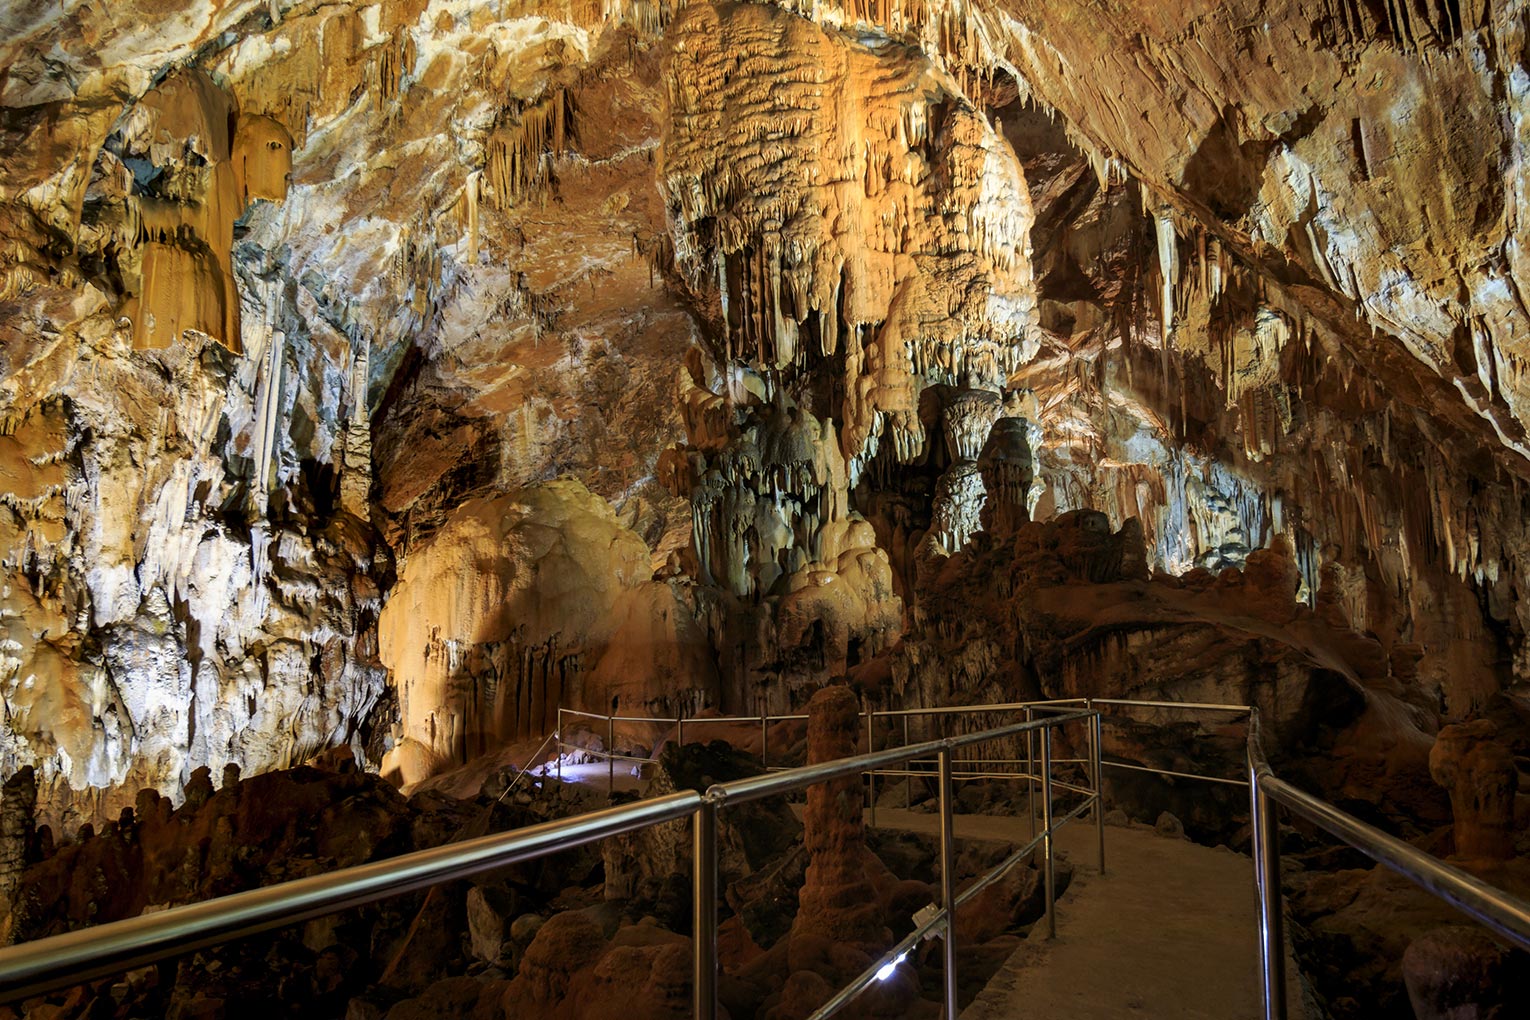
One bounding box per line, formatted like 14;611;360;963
41;699;1530;1020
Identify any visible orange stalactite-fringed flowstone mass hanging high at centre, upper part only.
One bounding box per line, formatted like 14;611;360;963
659;6;1037;485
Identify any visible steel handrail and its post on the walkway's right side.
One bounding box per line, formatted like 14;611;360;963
1248;711;1530;1020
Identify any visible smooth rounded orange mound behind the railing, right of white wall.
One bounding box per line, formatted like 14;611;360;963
379;480;716;783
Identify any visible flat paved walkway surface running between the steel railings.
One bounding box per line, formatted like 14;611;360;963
877;807;1304;1020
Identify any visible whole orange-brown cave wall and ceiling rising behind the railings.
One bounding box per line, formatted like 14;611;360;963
0;0;1530;1018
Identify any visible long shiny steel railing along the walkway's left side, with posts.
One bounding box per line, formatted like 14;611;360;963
0;711;1105;1020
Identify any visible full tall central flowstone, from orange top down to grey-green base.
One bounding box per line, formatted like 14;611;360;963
658;5;1034;707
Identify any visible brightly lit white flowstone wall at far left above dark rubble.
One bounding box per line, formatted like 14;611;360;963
0;307;387;824
